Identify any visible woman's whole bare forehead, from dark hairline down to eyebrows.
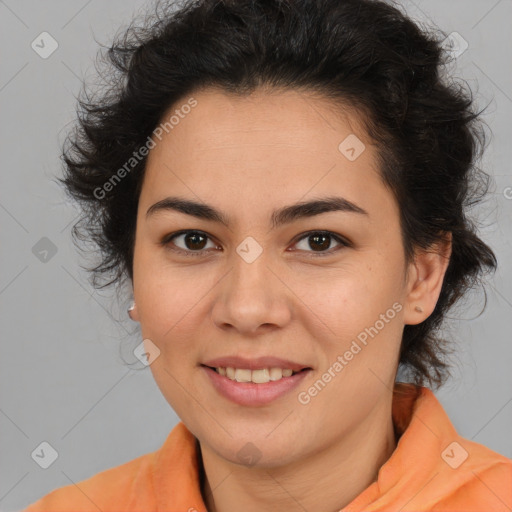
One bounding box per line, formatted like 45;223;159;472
141;89;389;226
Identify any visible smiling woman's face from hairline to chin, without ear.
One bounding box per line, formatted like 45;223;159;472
133;90;420;467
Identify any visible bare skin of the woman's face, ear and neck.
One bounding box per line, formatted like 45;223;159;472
129;89;450;512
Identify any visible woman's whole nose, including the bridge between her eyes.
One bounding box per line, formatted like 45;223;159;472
212;239;290;333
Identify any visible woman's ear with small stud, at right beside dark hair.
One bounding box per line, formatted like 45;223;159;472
404;233;452;325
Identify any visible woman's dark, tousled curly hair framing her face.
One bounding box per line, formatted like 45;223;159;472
61;0;496;386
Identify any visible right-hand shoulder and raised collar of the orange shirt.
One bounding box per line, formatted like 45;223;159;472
386;383;512;512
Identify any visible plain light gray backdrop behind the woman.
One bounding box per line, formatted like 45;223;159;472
0;0;512;511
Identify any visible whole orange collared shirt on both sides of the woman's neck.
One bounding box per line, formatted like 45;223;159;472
23;383;512;512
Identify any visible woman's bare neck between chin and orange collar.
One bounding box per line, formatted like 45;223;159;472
197;403;396;512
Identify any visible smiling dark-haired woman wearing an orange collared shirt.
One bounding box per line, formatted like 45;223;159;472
26;0;512;512
